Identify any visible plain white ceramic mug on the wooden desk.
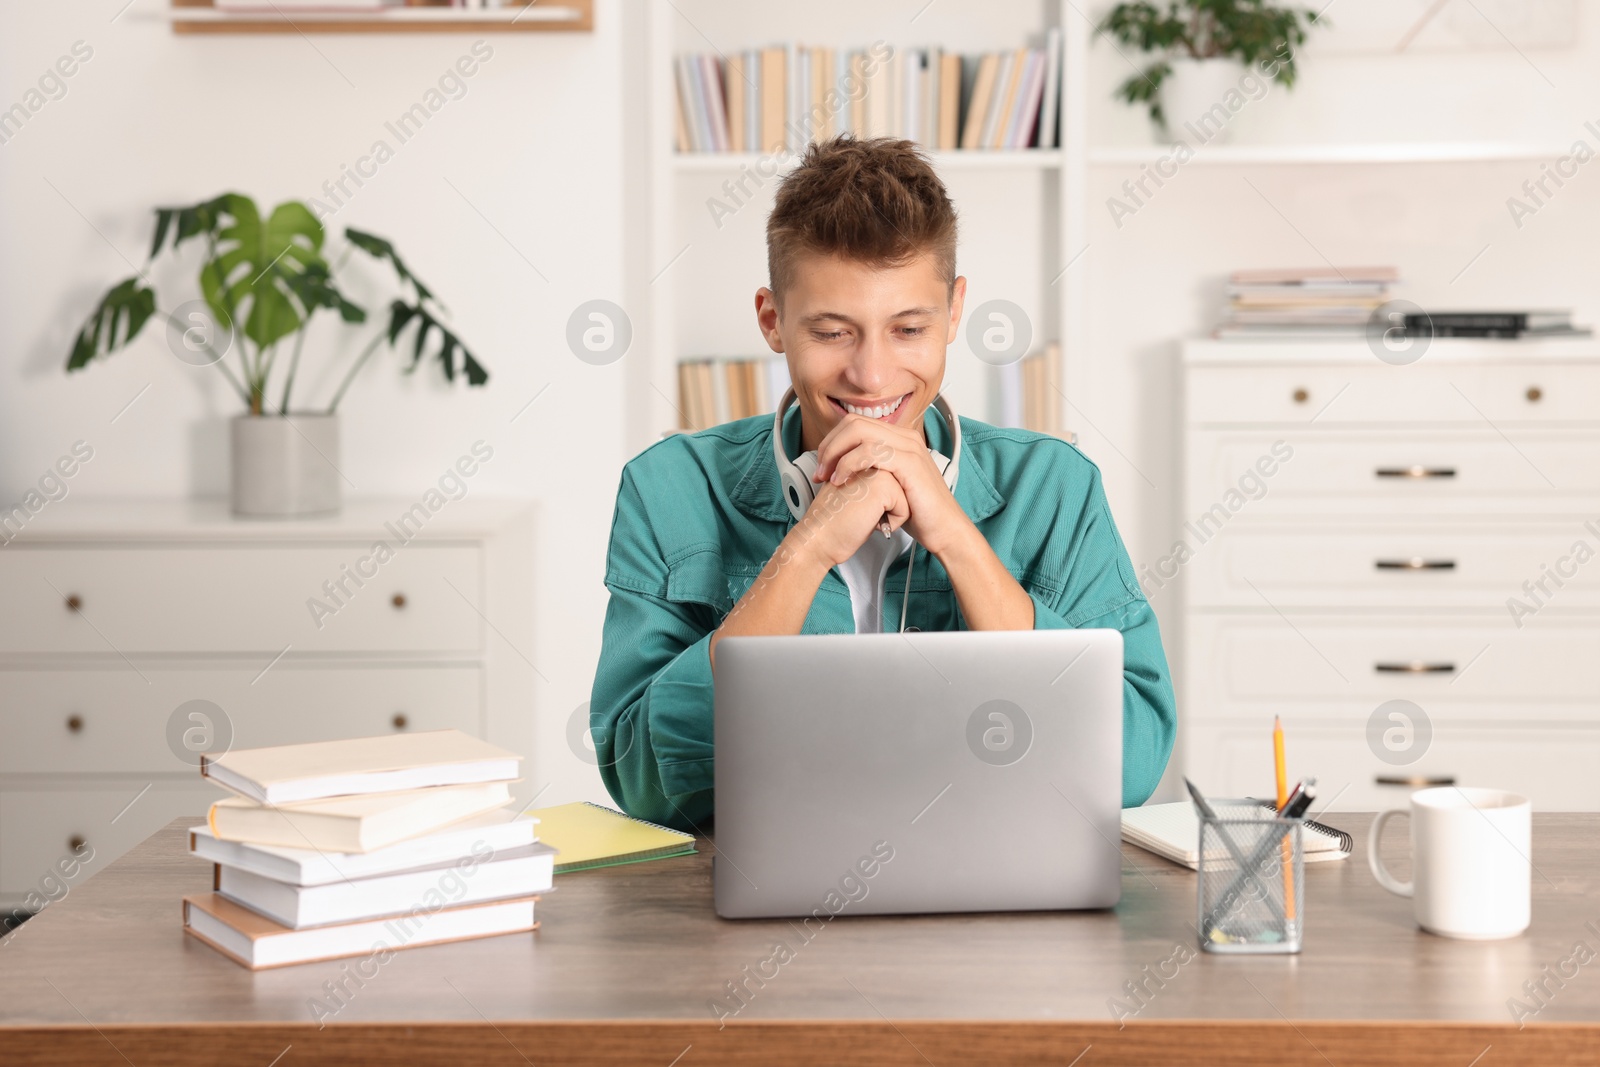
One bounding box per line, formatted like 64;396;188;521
1366;785;1533;941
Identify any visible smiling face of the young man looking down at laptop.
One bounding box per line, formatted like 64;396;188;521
755;253;966;451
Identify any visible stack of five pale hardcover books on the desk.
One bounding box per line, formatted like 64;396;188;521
184;729;555;969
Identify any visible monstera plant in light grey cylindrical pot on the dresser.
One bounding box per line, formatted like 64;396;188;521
67;192;490;517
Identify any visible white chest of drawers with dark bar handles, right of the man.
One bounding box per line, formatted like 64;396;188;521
1177;339;1600;811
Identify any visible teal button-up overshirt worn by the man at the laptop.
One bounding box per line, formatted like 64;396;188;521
589;410;1178;829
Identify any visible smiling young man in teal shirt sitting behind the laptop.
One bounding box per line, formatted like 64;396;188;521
590;136;1176;829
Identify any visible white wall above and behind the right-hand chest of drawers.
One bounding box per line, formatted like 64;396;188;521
1072;0;1600;793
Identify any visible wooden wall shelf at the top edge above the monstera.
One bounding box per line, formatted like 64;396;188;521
165;0;594;34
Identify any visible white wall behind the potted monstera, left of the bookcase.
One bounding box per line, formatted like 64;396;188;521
0;0;629;803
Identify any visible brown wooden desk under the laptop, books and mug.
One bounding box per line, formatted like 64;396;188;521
0;814;1600;1067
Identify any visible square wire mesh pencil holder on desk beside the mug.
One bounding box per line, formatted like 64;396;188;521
1195;800;1306;953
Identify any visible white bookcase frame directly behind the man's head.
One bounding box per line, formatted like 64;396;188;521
624;0;1091;451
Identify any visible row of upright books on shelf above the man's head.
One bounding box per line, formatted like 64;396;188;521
674;35;1062;154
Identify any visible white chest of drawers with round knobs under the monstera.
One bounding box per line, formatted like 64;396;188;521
0;496;533;909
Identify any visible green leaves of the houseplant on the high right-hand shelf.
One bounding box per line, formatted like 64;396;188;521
1096;0;1326;130
